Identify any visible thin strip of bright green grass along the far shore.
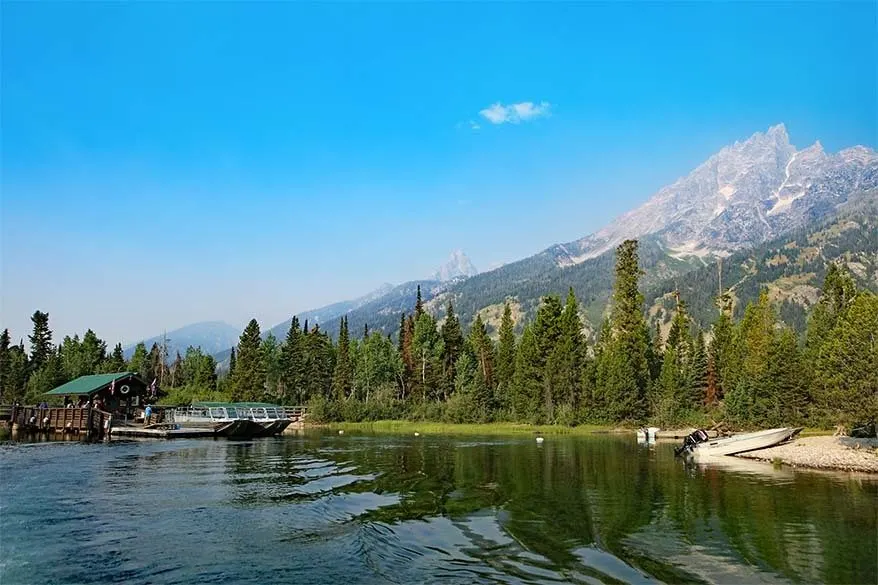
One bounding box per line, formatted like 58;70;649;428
320;420;634;435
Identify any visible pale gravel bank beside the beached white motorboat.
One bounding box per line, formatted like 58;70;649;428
737;436;878;473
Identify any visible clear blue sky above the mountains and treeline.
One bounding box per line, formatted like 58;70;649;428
0;2;878;343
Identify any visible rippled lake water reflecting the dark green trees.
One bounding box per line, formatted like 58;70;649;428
0;433;878;585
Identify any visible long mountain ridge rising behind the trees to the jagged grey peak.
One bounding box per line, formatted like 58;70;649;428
129;124;878;359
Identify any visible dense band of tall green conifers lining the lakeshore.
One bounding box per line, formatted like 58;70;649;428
0;240;878;427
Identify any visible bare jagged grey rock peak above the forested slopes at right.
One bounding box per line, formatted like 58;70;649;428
549;124;878;266
